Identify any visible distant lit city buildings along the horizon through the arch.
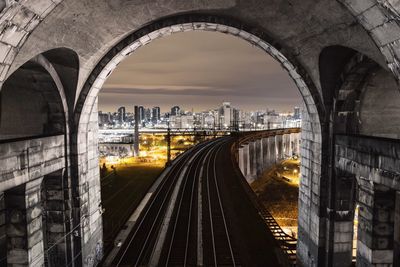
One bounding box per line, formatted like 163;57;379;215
99;102;301;130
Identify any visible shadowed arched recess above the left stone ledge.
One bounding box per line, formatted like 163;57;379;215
0;55;67;140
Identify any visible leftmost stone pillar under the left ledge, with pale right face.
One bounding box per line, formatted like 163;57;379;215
5;178;44;266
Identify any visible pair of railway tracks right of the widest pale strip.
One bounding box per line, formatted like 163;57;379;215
158;140;239;266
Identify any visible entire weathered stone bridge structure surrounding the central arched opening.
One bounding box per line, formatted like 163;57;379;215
0;0;400;266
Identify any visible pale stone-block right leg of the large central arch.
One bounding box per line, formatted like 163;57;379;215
297;105;326;266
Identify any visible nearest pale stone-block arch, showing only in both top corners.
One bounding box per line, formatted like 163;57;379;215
0;0;400;93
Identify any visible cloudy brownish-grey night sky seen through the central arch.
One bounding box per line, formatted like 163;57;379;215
99;31;302;112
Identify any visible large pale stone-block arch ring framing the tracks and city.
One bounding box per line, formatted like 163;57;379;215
72;14;325;267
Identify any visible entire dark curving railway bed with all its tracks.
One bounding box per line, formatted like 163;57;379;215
112;137;282;266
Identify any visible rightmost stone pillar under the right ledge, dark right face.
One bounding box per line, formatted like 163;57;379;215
356;184;395;266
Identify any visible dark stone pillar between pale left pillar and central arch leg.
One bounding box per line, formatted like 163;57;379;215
42;170;70;266
